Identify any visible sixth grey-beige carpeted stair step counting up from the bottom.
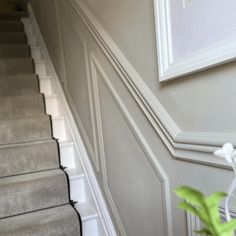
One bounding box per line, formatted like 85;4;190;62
0;74;39;96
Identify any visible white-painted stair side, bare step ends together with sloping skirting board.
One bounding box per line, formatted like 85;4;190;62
22;10;117;236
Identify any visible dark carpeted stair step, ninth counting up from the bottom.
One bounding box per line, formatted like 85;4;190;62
0;32;27;44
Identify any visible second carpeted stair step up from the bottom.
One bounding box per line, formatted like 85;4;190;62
0;169;69;218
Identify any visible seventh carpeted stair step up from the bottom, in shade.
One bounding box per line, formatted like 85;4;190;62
0;58;34;75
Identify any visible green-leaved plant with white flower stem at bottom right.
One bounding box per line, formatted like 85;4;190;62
175;143;236;236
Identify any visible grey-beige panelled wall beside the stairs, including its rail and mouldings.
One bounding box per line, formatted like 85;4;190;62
30;0;236;236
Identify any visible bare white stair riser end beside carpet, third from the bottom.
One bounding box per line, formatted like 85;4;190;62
59;143;75;168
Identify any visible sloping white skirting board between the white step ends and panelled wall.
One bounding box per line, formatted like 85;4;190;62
29;5;117;236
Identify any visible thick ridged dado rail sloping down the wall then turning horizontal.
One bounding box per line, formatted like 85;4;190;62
70;0;236;171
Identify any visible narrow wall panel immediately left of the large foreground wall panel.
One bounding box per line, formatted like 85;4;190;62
59;11;99;171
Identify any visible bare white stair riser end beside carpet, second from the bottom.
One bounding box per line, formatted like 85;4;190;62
69;176;87;202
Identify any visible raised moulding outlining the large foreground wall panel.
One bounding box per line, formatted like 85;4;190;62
90;53;173;236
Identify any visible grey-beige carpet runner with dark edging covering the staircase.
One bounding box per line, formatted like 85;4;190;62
0;9;81;236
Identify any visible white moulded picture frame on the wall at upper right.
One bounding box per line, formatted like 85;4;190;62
154;0;236;81
